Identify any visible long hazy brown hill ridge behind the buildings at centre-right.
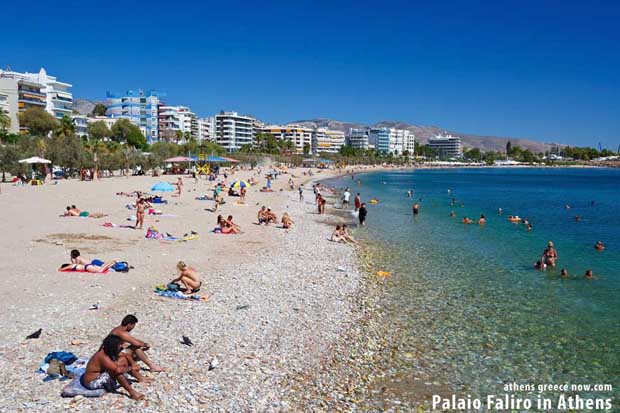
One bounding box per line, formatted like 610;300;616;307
289;118;564;153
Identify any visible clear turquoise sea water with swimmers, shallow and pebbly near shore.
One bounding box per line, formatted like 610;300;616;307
327;169;620;407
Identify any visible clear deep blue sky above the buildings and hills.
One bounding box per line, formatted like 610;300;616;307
0;0;620;150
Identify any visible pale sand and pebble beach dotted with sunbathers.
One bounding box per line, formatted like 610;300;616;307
0;169;372;412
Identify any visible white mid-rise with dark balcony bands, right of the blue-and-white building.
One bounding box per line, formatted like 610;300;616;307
215;111;256;152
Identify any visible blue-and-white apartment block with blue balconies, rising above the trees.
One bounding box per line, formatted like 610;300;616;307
106;90;164;143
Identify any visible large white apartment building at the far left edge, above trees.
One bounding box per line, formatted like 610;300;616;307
0;68;73;133
